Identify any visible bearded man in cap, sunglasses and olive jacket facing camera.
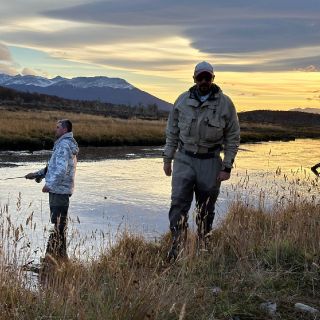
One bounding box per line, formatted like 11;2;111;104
163;61;240;259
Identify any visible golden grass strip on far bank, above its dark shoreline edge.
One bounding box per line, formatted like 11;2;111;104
0;110;165;139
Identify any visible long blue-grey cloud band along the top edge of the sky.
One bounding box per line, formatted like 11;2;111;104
43;0;320;26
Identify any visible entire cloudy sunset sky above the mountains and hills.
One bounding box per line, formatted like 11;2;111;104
0;0;320;111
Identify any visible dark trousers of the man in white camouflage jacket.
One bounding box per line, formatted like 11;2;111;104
46;193;70;258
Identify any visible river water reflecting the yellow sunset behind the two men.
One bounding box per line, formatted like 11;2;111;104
0;139;320;257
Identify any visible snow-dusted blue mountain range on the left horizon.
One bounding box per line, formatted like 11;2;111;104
0;74;172;111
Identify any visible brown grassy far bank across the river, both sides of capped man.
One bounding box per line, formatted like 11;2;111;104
0;106;320;151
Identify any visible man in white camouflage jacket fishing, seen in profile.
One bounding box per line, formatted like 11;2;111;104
25;119;79;258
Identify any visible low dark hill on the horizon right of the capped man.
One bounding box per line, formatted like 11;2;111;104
238;110;320;126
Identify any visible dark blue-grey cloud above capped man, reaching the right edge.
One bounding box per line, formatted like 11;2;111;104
184;18;320;54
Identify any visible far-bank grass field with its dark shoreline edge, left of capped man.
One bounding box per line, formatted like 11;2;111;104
0;110;165;148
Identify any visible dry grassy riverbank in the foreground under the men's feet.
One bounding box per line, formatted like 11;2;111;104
0;199;320;320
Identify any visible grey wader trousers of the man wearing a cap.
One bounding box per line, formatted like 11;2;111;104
169;152;222;235
